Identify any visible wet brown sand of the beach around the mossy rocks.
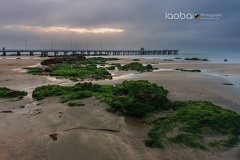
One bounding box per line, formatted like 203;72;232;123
0;56;240;160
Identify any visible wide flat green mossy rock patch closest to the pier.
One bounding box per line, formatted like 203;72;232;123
26;57;118;80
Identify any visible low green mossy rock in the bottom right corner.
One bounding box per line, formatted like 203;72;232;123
145;101;240;150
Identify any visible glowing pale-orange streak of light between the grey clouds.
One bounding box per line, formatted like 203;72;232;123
3;25;124;33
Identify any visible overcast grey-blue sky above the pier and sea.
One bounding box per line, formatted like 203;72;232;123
0;0;240;54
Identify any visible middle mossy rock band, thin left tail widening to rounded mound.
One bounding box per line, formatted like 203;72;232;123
33;80;172;118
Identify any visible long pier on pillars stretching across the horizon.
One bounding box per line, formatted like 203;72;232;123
0;48;178;57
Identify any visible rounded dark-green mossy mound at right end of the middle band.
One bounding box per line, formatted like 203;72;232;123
108;80;172;118
